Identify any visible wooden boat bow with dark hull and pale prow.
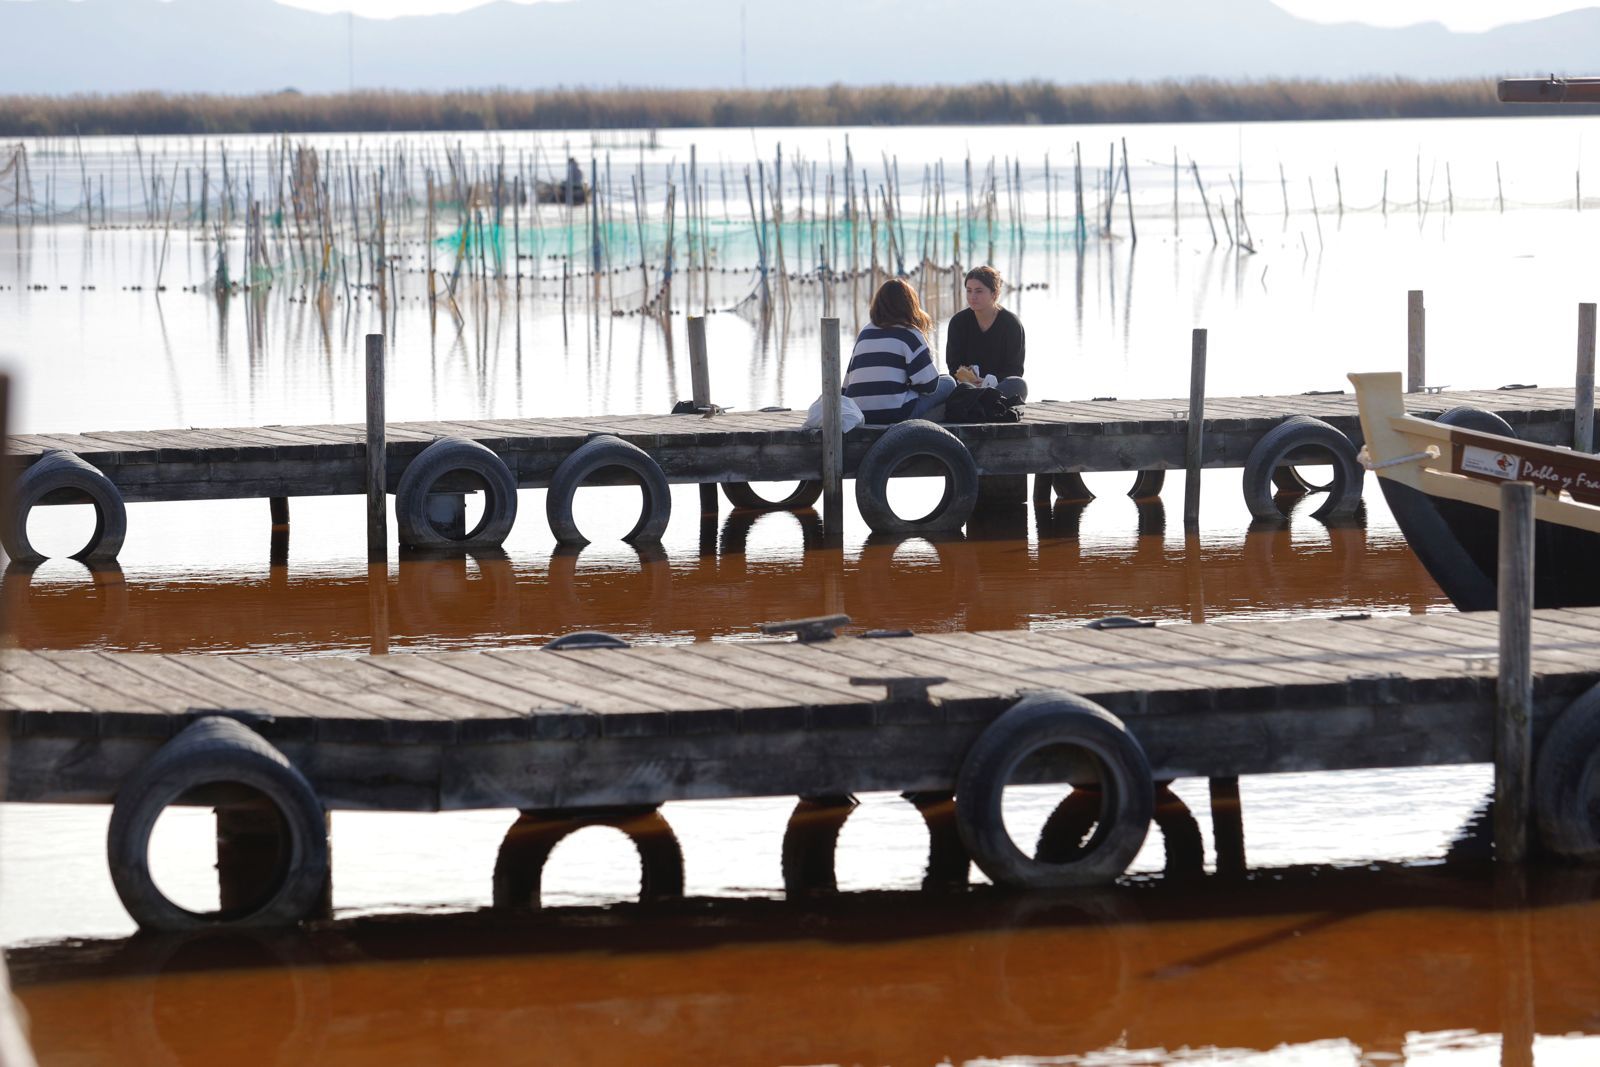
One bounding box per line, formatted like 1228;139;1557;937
1349;373;1600;611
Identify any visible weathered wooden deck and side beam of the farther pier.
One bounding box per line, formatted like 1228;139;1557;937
10;389;1573;501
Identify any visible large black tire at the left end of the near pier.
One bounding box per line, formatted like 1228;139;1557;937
106;715;328;931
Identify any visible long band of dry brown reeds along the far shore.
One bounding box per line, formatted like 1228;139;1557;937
0;78;1600;138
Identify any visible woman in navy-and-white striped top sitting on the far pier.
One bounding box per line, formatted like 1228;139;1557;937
845;278;955;426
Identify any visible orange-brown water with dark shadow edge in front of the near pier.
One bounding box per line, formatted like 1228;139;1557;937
11;865;1600;1064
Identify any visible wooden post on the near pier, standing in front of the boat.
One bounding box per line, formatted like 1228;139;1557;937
1494;482;1533;864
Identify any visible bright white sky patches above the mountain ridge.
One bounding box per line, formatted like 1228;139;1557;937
282;0;1600;30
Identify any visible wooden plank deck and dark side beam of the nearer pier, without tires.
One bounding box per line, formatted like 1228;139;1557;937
0;609;1600;811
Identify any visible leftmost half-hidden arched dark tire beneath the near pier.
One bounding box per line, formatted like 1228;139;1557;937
494;808;683;910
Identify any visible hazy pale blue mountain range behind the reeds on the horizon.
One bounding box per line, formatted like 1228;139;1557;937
0;0;1600;94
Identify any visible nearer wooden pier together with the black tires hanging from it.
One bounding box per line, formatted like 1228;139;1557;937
0;608;1600;928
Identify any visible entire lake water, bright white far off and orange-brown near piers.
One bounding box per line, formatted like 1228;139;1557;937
0;118;1600;1067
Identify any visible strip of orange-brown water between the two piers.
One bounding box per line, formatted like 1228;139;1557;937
0;502;1445;653
